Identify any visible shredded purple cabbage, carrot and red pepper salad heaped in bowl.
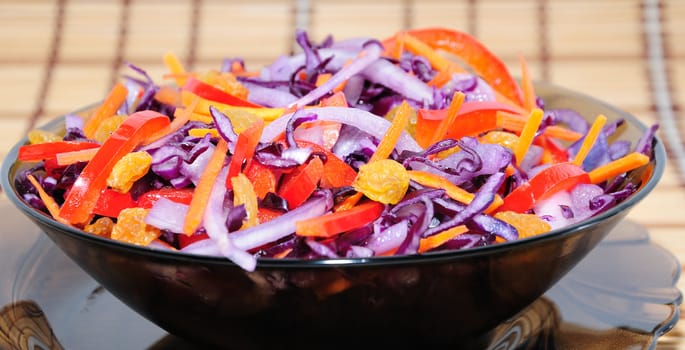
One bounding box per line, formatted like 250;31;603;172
15;28;657;270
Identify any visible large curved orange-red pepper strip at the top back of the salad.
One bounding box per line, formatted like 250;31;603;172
396;28;524;106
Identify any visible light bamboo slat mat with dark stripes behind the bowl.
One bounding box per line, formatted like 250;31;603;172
0;0;685;349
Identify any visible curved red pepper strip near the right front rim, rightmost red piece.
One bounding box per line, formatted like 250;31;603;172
496;162;590;213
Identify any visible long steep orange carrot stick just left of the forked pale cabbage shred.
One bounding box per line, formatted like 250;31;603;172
183;138;228;236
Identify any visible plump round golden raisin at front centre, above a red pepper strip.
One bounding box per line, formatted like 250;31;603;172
352;159;409;204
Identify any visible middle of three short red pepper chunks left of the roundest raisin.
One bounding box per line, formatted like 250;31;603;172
278;157;323;209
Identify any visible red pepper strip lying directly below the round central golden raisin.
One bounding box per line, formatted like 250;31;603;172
295;201;385;237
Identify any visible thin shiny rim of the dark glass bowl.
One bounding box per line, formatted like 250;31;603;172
0;82;667;270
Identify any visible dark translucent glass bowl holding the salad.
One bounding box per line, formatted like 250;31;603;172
1;84;666;349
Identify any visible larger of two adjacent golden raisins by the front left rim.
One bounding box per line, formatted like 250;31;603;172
112;208;161;246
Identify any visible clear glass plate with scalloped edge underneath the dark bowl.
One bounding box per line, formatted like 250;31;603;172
0;198;682;350
